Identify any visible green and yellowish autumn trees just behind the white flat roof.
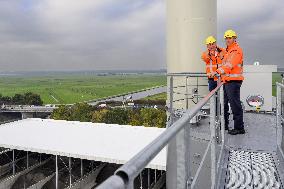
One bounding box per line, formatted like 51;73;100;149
51;103;167;128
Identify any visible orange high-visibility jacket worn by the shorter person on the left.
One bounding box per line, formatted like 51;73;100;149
201;47;226;81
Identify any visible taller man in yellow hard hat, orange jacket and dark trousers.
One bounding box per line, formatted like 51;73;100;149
216;30;245;135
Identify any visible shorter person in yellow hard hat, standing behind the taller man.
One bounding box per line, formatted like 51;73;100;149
201;36;225;91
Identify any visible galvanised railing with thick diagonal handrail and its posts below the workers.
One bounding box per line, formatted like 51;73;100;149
97;75;225;189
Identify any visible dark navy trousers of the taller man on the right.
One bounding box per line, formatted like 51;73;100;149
224;81;244;130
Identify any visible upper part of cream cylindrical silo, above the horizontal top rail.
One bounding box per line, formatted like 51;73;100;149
167;0;217;73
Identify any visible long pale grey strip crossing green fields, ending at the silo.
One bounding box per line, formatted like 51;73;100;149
88;86;167;106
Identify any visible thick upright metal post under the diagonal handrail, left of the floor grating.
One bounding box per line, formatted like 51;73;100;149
210;94;217;189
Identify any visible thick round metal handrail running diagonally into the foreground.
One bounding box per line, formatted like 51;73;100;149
98;83;223;189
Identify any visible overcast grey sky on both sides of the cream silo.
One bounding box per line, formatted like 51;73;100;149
0;0;284;71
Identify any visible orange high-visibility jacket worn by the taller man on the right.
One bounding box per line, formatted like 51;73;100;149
217;43;244;81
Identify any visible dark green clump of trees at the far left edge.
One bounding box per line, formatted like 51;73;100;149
0;92;43;106
